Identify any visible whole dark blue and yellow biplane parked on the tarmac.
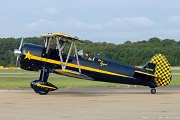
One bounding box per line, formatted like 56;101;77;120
14;33;172;95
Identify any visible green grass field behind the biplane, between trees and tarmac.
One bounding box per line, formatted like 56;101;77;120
0;69;180;88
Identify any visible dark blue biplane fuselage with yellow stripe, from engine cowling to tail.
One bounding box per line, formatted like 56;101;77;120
19;44;157;87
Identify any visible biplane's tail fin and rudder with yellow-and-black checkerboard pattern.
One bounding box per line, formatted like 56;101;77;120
143;54;172;86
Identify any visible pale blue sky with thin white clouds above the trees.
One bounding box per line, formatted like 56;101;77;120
0;0;180;44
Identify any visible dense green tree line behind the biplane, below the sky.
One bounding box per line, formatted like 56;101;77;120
0;37;180;66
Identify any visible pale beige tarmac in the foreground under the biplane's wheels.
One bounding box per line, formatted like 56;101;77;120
0;87;180;120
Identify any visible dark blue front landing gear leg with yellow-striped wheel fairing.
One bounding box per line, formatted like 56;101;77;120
30;68;58;95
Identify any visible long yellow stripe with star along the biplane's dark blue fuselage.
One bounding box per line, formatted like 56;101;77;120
24;52;133;78
